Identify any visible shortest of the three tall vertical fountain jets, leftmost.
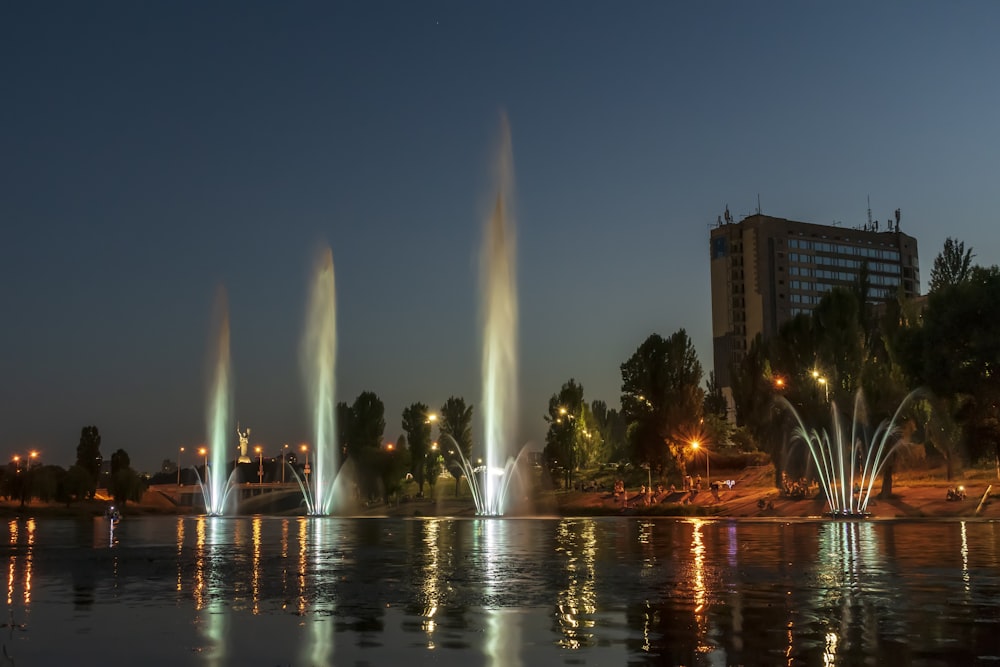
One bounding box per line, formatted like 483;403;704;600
201;287;232;516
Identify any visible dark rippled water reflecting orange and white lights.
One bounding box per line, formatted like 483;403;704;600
0;517;1000;666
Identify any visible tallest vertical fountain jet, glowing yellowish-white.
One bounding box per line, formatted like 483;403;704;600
477;116;517;516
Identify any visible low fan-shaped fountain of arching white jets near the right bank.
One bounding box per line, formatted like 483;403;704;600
779;391;917;517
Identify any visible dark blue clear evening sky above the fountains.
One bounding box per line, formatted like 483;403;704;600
0;2;1000;470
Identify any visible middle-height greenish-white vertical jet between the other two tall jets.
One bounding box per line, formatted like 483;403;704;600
300;248;340;515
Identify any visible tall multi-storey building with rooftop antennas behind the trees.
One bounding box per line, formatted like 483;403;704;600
710;209;920;406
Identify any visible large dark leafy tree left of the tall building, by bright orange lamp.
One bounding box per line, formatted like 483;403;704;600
621;329;705;478
